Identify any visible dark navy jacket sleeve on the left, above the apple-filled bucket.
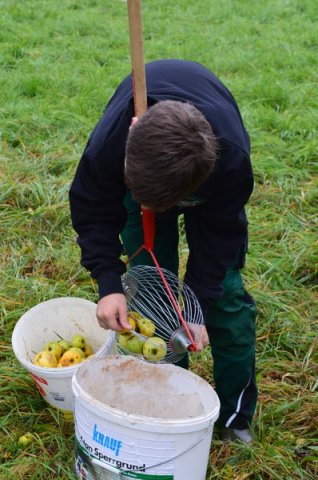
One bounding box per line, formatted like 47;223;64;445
69;108;130;297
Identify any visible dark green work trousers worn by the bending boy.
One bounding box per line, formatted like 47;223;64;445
121;193;257;429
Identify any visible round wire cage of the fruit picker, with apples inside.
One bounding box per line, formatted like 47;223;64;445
117;265;204;363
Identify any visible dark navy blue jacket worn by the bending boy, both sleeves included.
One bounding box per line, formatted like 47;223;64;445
70;60;253;314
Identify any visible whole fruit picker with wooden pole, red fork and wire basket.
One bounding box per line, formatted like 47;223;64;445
116;0;204;363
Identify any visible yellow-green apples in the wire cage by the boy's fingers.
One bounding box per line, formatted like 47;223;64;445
118;311;167;362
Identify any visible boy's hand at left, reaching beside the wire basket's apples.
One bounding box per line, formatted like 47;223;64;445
96;293;131;332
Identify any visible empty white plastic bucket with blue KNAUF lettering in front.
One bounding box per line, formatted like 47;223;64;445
72;355;220;480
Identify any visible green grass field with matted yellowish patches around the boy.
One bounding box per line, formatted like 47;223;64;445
0;0;318;480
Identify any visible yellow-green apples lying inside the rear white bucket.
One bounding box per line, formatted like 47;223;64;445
33;335;93;368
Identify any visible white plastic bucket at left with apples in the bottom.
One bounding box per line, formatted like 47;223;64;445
12;297;116;417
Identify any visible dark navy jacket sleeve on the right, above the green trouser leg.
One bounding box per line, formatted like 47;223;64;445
185;147;253;313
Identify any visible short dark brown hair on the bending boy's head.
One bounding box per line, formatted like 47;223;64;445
125;100;218;212
